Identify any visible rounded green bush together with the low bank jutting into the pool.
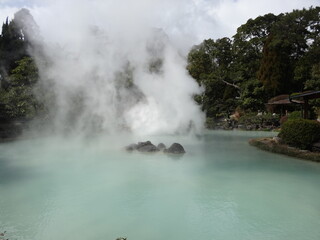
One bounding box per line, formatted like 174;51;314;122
249;119;320;162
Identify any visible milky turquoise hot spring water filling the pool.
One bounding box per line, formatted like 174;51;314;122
0;131;320;240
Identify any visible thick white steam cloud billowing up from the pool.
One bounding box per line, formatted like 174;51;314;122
27;0;204;134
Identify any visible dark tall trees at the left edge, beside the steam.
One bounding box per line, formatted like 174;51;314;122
0;9;41;122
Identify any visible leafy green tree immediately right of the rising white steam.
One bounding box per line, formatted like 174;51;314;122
187;38;240;118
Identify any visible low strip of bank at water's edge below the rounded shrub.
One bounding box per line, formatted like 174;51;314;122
249;138;320;162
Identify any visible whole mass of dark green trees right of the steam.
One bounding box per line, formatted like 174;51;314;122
187;7;320;118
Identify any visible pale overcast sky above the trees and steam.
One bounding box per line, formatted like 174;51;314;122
0;0;320;45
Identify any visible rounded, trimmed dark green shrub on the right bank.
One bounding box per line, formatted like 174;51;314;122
279;119;320;149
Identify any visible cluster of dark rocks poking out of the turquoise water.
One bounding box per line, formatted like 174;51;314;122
125;141;185;154
